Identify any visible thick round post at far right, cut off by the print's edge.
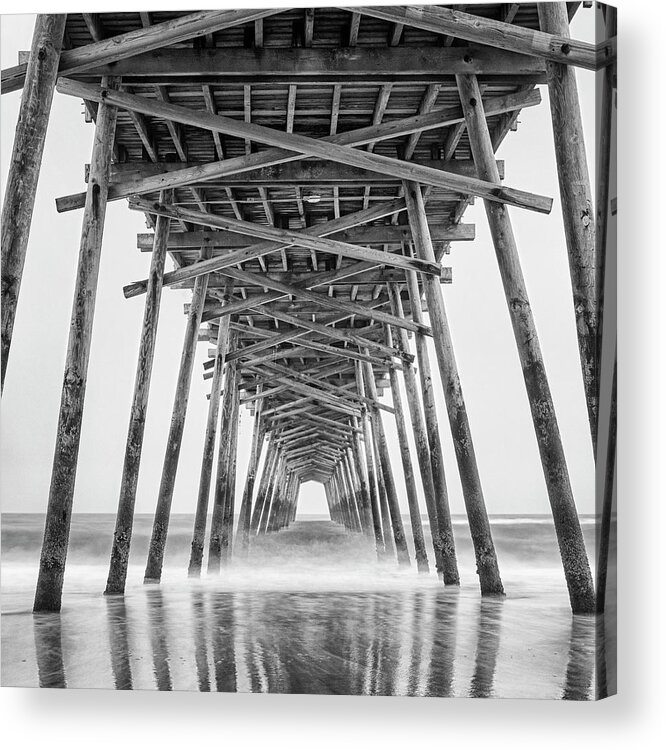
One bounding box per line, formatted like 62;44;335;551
537;2;600;455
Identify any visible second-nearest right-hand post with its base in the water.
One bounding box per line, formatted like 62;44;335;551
404;182;504;595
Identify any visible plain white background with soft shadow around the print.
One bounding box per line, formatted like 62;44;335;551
0;0;666;750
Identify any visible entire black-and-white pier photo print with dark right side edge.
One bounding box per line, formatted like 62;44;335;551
1;2;616;700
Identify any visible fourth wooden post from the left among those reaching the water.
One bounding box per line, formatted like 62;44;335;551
188;280;234;578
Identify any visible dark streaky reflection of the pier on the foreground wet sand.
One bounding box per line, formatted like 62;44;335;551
26;586;596;700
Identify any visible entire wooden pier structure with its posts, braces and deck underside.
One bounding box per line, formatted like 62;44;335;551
2;2;616;613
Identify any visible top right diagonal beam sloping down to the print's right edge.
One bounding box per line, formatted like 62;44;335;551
347;5;615;74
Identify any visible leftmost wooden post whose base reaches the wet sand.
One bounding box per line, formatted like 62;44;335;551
34;79;118;612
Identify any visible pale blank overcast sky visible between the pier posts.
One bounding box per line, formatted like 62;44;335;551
0;3;594;513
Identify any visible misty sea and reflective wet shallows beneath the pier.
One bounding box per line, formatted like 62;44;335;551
2;514;598;700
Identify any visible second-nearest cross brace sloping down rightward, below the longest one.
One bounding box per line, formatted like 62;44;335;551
129;199;442;276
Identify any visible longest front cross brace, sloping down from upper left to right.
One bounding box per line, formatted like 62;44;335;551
57;83;552;213
